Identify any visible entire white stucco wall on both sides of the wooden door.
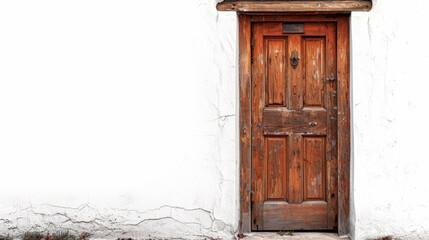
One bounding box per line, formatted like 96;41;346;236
0;0;429;240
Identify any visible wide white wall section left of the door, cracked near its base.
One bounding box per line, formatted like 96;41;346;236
0;0;238;239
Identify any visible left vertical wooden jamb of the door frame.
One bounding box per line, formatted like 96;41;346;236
238;15;252;232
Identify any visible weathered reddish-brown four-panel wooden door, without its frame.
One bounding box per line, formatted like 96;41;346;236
251;22;338;230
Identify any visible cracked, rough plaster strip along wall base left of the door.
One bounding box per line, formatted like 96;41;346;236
0;204;234;239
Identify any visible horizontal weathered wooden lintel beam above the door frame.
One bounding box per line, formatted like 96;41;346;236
216;0;372;12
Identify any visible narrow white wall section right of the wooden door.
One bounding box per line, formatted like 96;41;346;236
351;0;429;239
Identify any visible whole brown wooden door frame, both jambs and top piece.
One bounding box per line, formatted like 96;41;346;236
238;13;350;236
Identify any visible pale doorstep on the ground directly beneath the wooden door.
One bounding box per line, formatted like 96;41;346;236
243;232;349;240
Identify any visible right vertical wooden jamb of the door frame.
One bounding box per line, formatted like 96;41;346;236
337;16;350;236
